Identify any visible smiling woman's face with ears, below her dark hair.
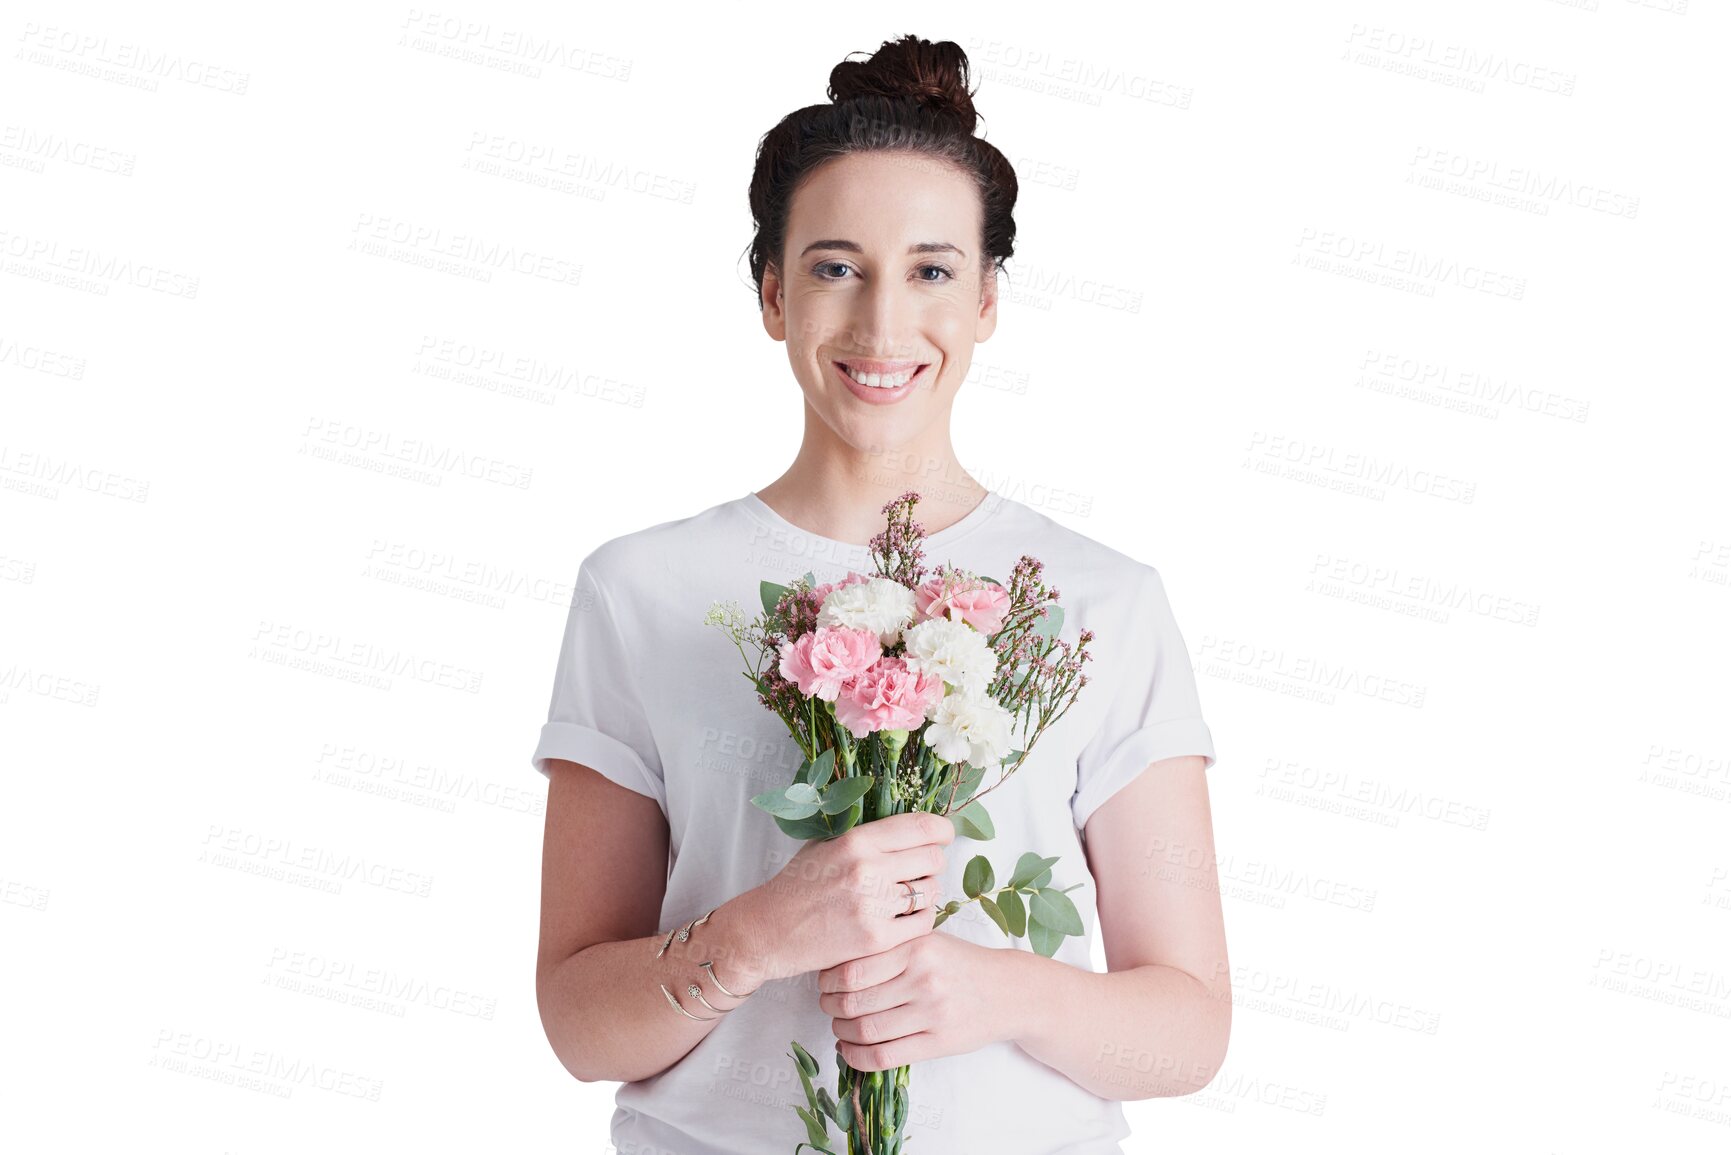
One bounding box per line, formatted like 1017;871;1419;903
763;152;997;452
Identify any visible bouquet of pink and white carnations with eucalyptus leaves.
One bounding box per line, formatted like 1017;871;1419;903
705;492;1094;1155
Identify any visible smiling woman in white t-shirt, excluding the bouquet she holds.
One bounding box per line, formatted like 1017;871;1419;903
533;36;1231;1155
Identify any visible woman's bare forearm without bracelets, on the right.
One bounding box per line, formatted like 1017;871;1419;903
1001;951;1232;1100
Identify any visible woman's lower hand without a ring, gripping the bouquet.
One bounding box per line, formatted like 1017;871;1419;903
817;930;1007;1070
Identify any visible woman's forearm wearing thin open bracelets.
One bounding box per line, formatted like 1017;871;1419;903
535;890;777;1082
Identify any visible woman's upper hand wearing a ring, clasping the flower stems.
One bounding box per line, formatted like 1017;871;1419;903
760;812;956;977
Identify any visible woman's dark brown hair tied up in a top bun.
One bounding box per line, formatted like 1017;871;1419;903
751;35;1016;303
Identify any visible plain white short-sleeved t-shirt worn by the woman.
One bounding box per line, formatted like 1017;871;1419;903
533;494;1215;1155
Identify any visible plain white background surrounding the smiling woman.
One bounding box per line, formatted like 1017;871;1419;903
0;0;1731;1155
